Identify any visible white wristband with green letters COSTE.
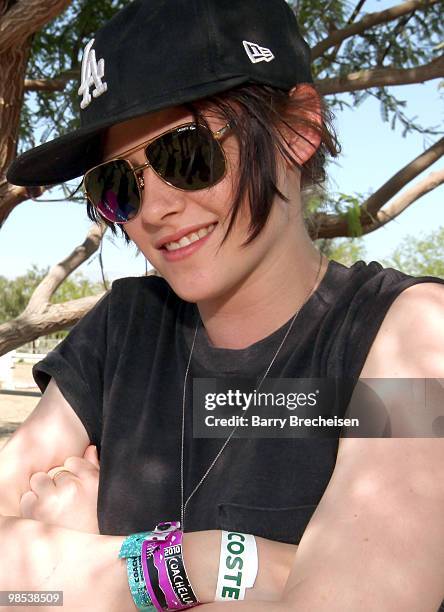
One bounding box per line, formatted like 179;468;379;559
215;531;258;601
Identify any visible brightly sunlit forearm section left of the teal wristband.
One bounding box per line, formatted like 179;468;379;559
0;516;134;612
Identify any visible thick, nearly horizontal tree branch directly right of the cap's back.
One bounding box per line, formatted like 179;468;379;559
316;55;444;96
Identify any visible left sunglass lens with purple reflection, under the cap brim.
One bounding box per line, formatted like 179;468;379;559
85;160;140;223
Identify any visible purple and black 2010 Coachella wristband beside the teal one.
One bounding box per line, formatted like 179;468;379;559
142;521;200;611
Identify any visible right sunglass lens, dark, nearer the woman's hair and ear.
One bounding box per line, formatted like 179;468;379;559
145;124;225;191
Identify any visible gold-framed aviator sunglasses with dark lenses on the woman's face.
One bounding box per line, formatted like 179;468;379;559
83;123;230;224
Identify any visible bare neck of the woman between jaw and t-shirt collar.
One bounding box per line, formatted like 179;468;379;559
197;241;328;349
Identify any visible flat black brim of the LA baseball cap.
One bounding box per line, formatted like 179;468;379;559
6;75;253;187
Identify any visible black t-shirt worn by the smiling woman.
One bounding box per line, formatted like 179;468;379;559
34;261;444;544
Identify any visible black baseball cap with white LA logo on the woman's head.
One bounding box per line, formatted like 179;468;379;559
7;0;313;187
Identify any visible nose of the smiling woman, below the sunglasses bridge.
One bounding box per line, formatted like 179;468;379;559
139;166;187;225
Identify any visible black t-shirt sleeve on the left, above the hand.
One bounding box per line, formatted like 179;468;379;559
32;293;110;448
